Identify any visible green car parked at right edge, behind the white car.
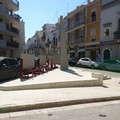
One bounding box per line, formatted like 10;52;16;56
101;60;120;71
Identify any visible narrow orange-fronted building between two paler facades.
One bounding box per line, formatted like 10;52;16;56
85;0;101;60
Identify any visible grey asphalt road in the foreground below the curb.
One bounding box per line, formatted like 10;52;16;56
0;101;120;120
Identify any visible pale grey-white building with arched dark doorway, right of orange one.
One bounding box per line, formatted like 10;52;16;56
100;0;120;60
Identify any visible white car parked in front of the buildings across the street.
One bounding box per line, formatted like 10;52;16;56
77;58;100;69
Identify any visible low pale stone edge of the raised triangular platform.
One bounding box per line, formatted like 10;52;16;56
0;78;103;91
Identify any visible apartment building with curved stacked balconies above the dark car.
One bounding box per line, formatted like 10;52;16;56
0;0;25;57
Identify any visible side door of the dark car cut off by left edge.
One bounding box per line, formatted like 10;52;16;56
0;59;9;80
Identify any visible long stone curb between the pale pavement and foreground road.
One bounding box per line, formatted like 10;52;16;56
0;96;120;113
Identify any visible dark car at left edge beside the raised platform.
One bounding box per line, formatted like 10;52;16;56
0;57;20;80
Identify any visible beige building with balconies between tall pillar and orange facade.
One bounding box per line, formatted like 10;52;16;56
65;5;86;59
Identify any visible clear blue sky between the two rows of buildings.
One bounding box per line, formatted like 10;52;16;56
18;0;86;41
